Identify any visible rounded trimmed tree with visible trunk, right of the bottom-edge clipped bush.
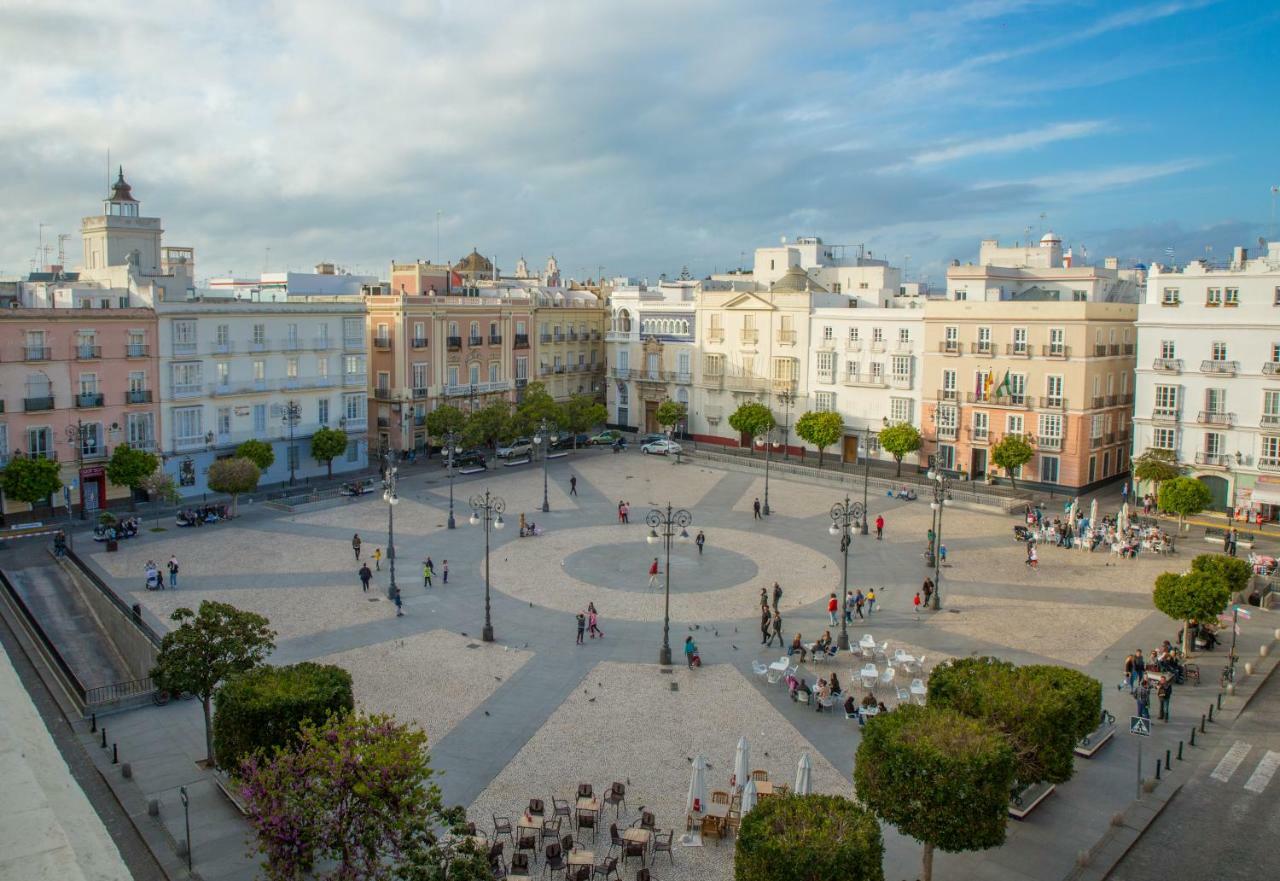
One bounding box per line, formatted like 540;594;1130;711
855;704;1014;881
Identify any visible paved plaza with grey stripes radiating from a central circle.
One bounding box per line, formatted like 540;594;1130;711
74;449;1264;880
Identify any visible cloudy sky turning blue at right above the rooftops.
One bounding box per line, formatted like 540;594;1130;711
0;0;1280;286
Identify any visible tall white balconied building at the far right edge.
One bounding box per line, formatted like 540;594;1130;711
1133;242;1280;520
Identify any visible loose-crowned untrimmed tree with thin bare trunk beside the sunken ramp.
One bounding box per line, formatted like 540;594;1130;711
151;599;275;762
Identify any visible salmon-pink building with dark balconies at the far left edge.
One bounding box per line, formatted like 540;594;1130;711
0;309;156;513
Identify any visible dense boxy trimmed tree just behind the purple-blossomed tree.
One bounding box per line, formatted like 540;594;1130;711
214;662;356;771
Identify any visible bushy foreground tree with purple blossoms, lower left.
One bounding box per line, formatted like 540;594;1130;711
241;713;457;881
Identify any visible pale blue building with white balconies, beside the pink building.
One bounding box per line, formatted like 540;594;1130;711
156;296;369;494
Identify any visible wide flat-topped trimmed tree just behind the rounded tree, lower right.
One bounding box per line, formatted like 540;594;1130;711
929;657;1102;786
